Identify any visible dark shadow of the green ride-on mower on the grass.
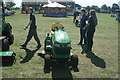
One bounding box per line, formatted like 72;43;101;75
38;53;74;80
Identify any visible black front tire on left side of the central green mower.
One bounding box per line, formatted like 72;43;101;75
44;55;51;73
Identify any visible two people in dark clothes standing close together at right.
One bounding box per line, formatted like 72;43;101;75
73;9;98;55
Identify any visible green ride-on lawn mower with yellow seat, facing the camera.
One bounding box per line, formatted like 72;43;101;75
44;23;78;72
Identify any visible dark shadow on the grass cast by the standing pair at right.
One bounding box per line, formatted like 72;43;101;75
87;53;106;68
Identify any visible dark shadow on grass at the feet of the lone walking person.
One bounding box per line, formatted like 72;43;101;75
20;48;39;63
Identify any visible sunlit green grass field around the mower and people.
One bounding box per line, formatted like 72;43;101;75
2;11;118;78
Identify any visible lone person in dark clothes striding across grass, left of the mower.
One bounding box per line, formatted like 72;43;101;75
21;9;41;48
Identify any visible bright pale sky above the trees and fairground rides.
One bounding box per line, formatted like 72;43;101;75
14;0;120;7
